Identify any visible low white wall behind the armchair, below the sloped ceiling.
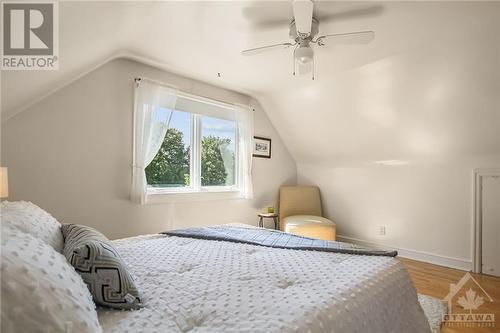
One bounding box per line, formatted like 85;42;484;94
298;156;500;269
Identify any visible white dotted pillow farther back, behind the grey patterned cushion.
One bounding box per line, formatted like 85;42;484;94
0;201;64;253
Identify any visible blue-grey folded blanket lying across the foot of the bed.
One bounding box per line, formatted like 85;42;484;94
162;225;398;257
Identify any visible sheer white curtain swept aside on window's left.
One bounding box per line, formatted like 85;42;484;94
130;80;177;204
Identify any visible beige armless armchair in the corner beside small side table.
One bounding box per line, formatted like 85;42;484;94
279;186;336;240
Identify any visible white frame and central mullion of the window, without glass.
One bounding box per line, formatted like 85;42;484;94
147;93;241;197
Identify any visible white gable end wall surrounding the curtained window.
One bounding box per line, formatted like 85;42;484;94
1;59;296;238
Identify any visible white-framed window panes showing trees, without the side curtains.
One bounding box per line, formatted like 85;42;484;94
145;95;239;193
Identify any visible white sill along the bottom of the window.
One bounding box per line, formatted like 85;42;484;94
146;188;240;204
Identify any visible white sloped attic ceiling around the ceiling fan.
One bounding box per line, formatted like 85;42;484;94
2;1;500;163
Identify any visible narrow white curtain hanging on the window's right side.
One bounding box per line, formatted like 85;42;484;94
236;107;253;199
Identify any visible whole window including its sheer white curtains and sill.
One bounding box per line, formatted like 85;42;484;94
130;78;253;204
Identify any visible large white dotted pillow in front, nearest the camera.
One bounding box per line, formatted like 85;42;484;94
1;225;102;333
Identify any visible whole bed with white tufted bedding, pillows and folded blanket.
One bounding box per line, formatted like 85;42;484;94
0;202;430;333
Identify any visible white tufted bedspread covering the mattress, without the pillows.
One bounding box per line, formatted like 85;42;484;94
98;235;429;333
